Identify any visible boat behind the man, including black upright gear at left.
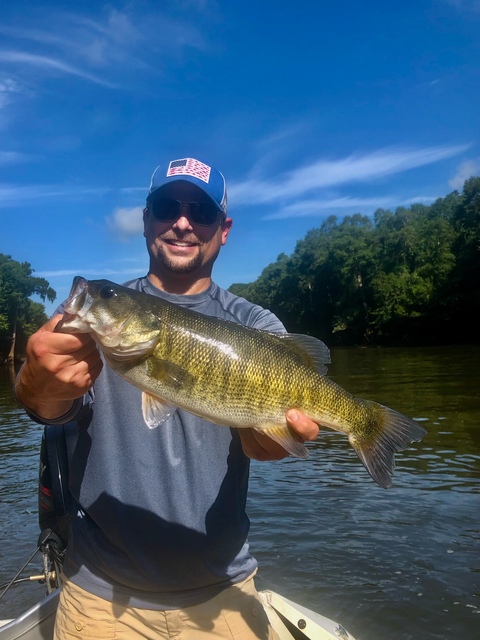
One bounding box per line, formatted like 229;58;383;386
0;432;355;640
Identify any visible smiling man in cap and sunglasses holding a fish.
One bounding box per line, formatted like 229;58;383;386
16;158;318;640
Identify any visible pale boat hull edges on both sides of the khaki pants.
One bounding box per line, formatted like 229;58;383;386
0;589;355;640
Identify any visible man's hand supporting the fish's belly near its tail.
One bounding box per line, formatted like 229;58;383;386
239;409;320;460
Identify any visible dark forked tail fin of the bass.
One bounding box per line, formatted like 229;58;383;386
349;400;426;489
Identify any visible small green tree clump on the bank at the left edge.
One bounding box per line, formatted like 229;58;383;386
0;253;56;362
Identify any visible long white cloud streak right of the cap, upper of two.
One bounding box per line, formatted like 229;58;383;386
229;145;468;205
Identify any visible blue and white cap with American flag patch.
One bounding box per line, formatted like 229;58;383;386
147;158;227;214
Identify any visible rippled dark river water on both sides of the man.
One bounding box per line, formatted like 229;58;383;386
0;346;480;640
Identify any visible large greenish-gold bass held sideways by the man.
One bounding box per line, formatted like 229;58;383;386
55;277;425;488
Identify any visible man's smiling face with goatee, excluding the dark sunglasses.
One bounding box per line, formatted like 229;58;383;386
144;182;232;277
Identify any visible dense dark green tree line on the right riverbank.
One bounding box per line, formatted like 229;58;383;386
230;177;480;345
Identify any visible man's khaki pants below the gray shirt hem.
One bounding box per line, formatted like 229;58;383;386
54;575;278;640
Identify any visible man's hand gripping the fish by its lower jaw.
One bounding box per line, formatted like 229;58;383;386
16;315;103;419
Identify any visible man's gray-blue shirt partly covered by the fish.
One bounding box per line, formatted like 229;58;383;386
52;278;285;609
